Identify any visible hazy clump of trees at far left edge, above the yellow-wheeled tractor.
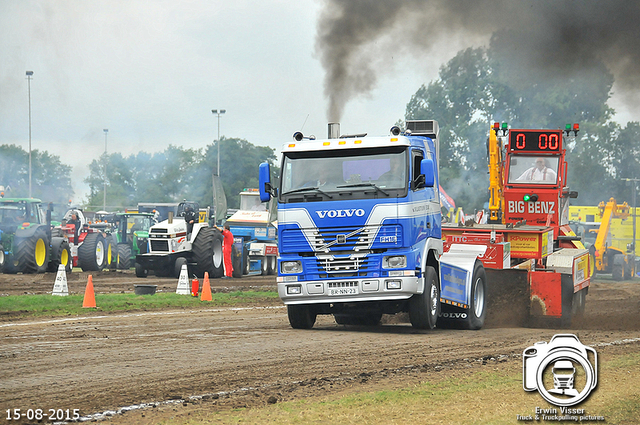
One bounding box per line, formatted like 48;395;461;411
0;145;73;203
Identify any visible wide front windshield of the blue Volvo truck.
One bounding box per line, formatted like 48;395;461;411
281;147;408;200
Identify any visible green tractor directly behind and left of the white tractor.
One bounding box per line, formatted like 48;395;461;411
109;212;156;270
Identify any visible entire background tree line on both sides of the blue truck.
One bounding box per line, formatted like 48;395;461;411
0;41;640;214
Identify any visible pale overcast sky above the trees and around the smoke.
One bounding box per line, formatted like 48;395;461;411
0;0;638;202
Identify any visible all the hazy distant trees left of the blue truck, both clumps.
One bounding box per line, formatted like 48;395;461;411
0;137;277;210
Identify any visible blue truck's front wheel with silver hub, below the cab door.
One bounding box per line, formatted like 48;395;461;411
409;266;440;329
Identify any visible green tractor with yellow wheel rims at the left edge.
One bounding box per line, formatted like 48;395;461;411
0;198;72;273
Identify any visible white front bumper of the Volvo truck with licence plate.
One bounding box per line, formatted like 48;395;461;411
278;276;423;305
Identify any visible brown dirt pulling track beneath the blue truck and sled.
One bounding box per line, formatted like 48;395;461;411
0;272;640;423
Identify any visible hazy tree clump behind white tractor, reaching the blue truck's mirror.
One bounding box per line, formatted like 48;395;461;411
85;137;276;209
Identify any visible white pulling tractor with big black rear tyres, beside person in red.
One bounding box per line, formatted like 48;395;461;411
135;201;224;278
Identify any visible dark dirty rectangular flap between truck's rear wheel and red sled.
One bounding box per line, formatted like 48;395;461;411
485;269;531;327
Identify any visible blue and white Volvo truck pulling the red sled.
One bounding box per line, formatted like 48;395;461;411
259;120;487;329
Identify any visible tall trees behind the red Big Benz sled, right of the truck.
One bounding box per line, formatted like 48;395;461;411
405;42;640;209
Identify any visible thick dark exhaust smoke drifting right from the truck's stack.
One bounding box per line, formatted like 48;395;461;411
316;0;640;121
